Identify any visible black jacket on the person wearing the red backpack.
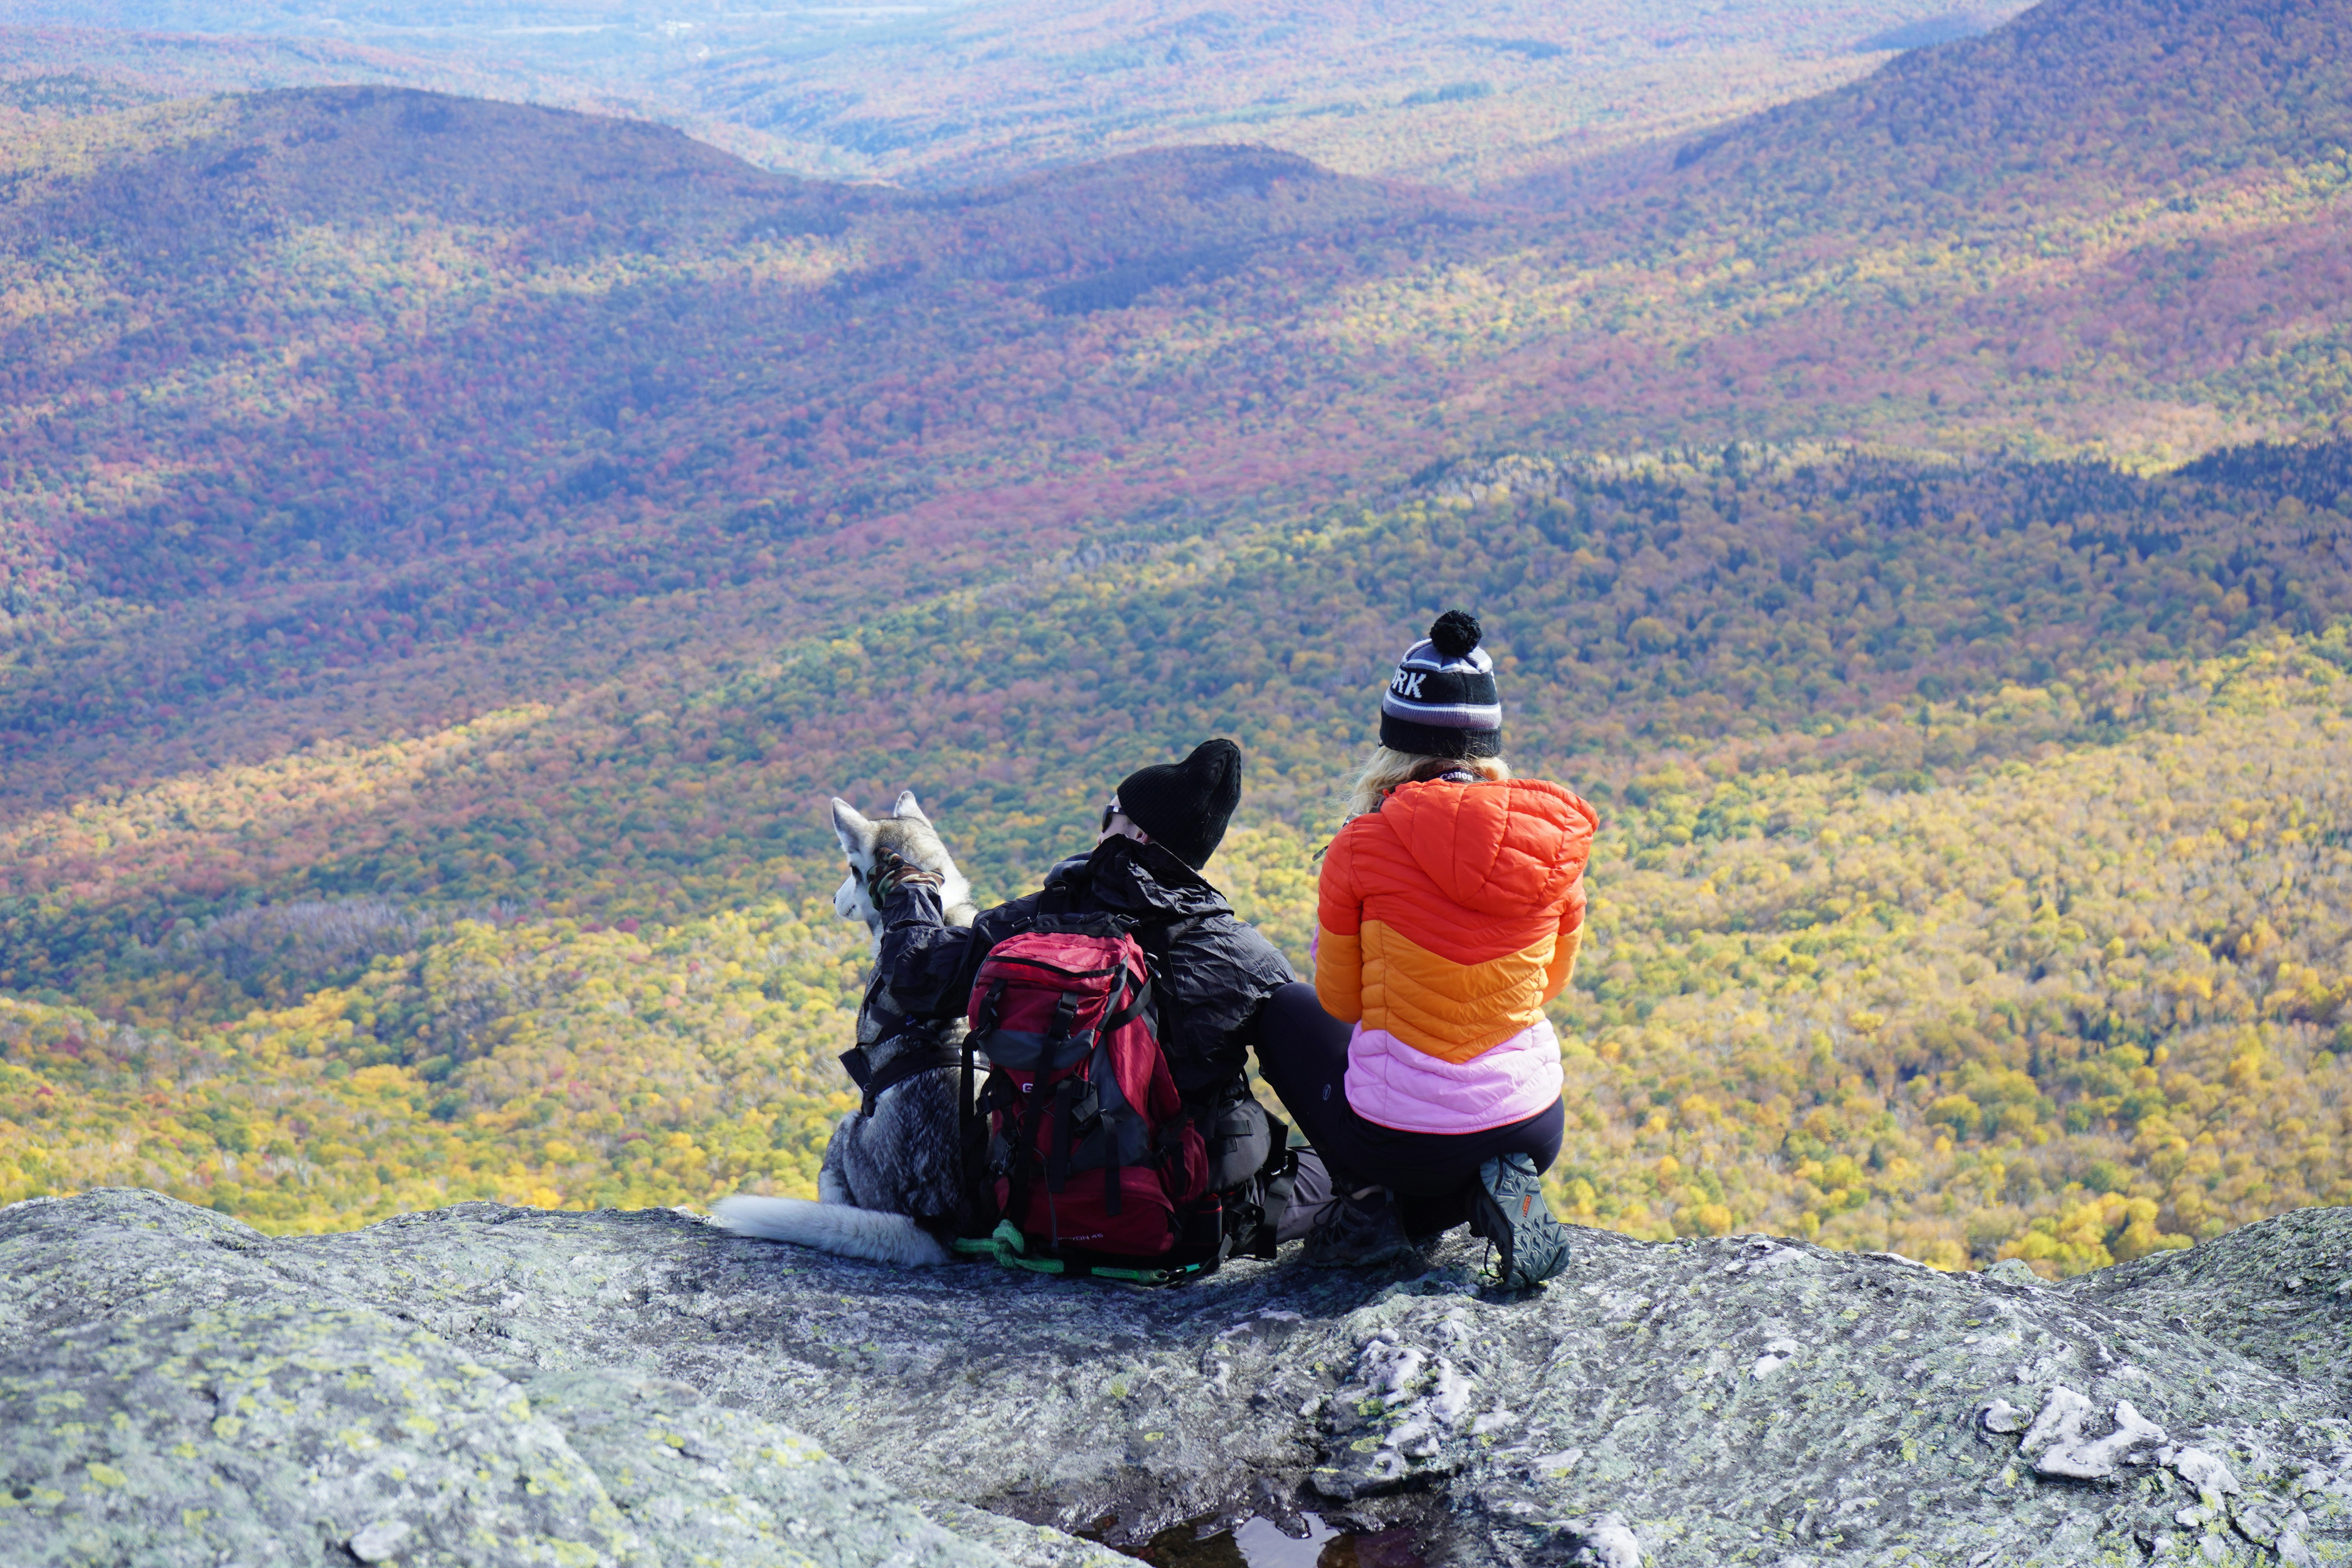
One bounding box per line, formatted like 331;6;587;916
875;837;1296;1107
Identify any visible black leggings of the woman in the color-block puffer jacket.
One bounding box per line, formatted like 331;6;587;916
1254;983;1566;1236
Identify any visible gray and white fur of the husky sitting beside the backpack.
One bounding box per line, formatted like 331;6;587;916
713;790;978;1267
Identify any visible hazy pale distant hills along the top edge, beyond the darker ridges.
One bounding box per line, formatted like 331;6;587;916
0;0;2018;191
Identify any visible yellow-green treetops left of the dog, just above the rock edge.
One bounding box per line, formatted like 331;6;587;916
0;900;866;1229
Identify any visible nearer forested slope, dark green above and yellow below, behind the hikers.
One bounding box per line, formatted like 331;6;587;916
0;449;2352;1272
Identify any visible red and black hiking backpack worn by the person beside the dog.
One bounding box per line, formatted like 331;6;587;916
957;919;1225;1283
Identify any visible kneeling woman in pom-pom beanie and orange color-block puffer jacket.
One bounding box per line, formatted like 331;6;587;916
1256;609;1597;1288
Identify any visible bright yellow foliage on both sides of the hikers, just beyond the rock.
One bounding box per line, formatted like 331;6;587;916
0;637;2352;1274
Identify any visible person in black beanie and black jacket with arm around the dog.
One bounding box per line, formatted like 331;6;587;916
873;740;1296;1255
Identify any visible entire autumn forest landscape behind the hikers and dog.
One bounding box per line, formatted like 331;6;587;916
0;0;2352;1276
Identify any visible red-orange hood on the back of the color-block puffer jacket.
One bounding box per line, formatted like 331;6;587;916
1381;778;1599;910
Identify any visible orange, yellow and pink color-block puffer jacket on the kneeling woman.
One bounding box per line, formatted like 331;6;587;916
1315;778;1599;1133
